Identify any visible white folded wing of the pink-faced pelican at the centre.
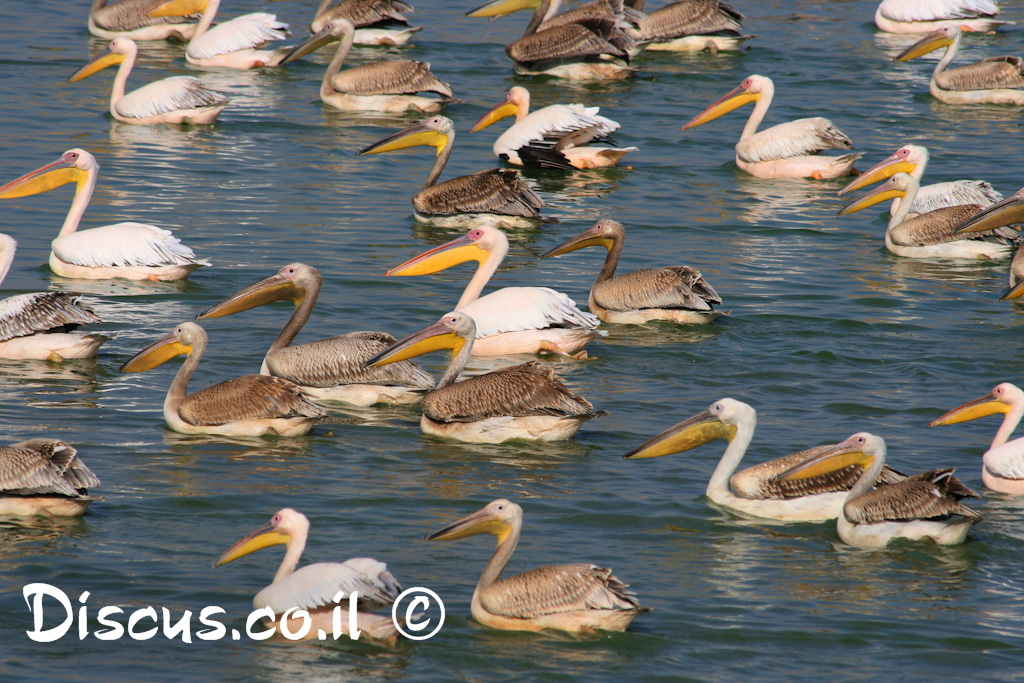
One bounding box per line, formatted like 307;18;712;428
462;287;601;339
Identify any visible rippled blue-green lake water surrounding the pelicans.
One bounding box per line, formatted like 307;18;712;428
0;0;1024;681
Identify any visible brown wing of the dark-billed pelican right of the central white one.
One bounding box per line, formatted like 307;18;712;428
591;265;722;310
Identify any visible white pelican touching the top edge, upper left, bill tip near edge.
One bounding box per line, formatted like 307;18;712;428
150;0;292;70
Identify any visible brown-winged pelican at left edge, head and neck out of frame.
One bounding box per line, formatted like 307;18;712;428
0;438;99;517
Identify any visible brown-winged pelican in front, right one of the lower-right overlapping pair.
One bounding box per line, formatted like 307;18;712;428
782;432;981;549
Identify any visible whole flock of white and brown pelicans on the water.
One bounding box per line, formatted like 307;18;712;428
0;0;1024;641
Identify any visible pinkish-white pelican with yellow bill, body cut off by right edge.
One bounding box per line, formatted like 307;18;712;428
929;382;1024;496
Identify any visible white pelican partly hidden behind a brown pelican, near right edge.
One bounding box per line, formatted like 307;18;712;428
839;144;1002;214
